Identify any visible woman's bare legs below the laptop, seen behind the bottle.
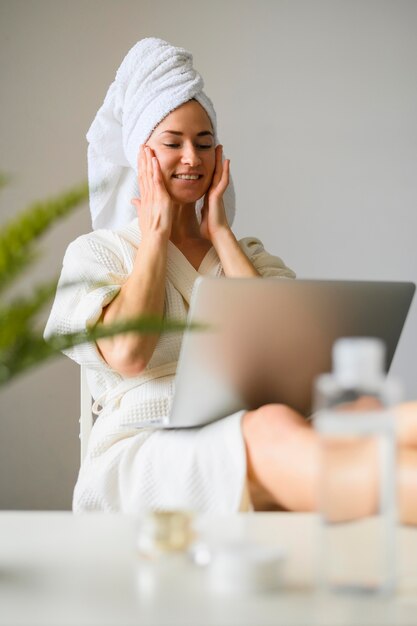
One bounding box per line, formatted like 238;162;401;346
242;403;417;524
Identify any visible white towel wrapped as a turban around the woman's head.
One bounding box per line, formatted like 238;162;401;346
87;37;235;230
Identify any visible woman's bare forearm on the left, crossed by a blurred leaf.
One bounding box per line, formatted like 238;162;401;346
97;234;168;376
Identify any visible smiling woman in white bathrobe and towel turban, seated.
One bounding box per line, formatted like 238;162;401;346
46;39;417;519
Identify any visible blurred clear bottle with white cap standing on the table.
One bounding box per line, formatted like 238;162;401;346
313;338;401;593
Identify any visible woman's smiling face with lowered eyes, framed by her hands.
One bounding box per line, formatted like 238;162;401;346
146;100;215;204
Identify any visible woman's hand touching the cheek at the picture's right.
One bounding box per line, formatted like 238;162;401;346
200;145;230;244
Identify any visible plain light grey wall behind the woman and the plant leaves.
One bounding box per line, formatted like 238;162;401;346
0;0;417;509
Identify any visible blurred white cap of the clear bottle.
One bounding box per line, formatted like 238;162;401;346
333;337;385;386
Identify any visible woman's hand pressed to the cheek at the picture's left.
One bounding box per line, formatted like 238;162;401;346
131;145;173;239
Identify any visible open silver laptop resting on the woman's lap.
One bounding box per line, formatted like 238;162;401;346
159;277;415;428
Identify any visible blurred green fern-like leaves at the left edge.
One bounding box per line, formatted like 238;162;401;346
0;172;197;387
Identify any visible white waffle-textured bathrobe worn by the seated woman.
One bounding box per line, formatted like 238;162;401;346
45;219;294;514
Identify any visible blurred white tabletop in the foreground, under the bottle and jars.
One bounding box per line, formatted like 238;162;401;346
0;512;417;626
